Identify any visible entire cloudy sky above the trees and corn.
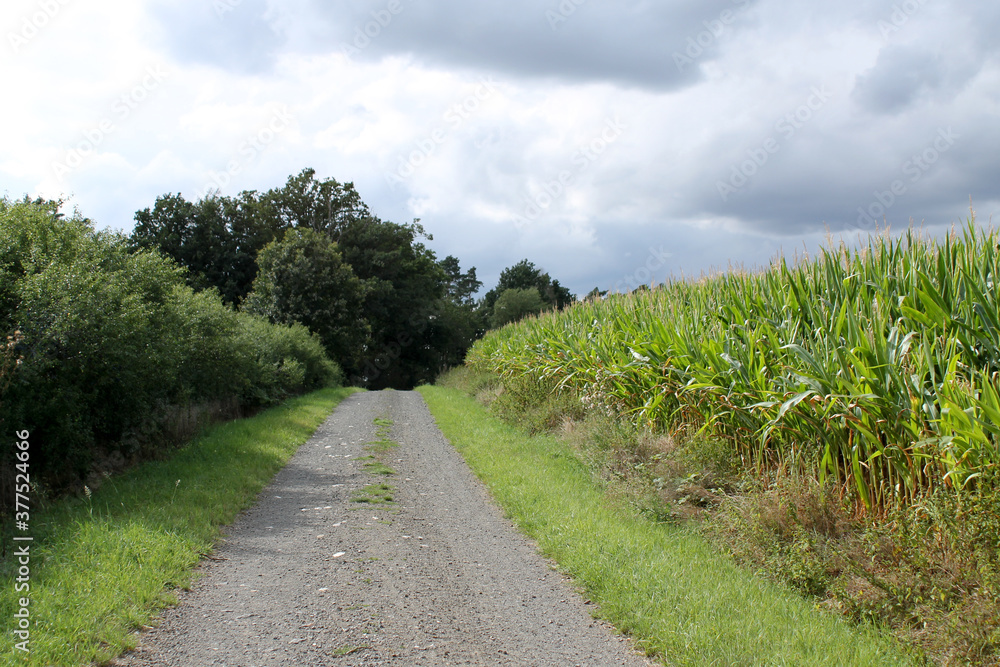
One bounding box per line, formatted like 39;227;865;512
0;0;1000;293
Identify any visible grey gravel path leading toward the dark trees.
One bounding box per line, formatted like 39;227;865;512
111;391;650;667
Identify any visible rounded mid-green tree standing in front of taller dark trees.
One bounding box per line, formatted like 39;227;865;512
243;229;370;366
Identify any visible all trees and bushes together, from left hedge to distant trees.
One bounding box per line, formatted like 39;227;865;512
0;169;573;500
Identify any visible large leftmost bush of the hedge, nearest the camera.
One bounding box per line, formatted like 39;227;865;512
0;204;181;485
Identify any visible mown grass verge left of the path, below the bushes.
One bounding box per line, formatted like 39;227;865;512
0;389;356;666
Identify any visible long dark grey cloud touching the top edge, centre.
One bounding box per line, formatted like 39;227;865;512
304;0;755;89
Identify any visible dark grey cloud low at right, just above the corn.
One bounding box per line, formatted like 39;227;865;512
662;114;1000;236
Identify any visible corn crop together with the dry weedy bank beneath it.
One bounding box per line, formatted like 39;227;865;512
469;223;1000;665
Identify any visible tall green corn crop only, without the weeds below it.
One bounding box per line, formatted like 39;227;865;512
468;220;1000;511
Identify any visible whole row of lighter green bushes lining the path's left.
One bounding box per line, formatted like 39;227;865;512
0;200;338;498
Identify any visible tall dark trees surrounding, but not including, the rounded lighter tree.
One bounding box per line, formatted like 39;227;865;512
130;169;486;388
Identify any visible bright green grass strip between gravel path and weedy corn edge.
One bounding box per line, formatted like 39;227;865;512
419;387;909;665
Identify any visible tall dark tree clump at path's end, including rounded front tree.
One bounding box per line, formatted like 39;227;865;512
130;169;484;388
